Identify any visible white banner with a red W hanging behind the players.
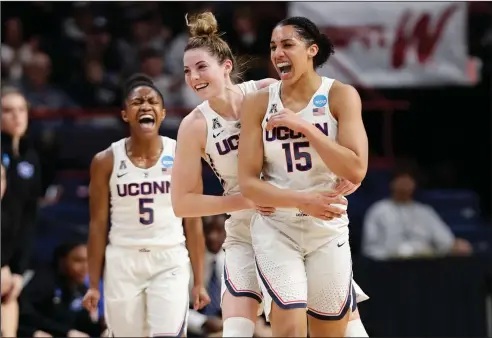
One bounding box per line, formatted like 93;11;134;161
289;1;471;87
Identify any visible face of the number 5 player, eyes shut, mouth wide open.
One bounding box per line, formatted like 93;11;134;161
121;86;166;136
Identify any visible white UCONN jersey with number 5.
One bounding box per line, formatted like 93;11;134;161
109;137;185;247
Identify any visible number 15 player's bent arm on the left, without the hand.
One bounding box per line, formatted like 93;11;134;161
238;90;306;208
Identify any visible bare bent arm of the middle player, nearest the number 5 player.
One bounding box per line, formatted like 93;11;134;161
171;111;253;217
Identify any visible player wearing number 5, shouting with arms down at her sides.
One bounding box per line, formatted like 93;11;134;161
84;75;209;337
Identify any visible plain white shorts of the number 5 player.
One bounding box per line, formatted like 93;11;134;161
104;244;190;337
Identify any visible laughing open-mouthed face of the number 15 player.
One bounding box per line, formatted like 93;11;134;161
270;25;318;82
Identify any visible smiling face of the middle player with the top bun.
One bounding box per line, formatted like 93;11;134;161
183;48;232;100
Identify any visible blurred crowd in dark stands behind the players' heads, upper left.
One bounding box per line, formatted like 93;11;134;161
1;2;285;113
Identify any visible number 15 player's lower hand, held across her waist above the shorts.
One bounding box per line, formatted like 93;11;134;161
299;192;347;221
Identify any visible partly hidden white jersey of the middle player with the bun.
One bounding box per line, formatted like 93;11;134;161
198;81;258;218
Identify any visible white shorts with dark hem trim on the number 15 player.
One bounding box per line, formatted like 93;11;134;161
251;214;355;320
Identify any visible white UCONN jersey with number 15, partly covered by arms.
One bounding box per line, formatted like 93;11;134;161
262;77;348;232
